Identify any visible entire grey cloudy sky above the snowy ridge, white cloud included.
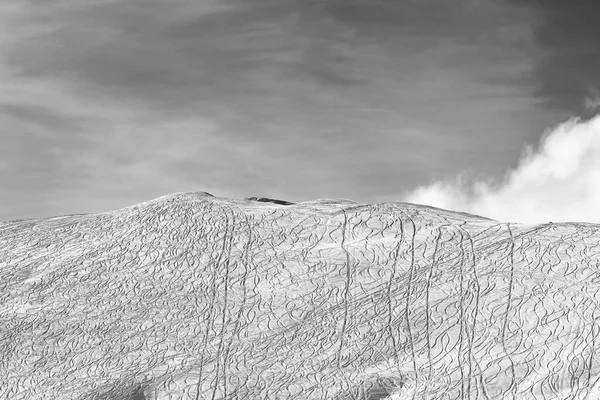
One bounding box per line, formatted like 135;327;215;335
0;0;600;222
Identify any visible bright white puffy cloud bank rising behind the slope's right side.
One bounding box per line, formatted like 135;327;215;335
404;114;600;223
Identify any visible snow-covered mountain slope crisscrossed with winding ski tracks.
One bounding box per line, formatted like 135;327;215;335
0;193;600;400
